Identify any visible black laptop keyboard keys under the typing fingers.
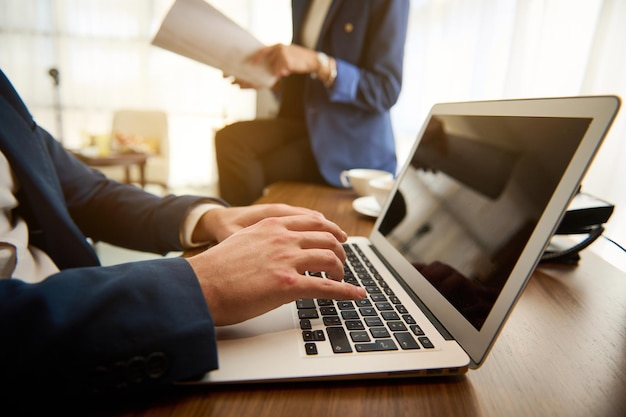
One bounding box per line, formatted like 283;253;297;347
296;244;434;355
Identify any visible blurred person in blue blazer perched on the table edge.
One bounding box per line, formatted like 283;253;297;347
215;0;409;205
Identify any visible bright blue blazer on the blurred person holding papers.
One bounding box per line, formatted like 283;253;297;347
292;0;409;186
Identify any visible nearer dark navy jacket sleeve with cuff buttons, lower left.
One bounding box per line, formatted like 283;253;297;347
0;258;218;394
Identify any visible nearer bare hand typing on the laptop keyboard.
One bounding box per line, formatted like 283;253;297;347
187;213;365;326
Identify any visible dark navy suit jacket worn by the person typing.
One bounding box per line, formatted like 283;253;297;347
0;71;217;401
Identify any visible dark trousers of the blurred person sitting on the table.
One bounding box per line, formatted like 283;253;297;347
215;118;326;206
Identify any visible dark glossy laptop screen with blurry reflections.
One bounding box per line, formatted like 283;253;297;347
379;115;591;330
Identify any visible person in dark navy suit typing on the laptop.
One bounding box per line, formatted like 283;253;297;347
0;71;363;406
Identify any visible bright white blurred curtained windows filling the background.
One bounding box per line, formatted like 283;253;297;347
0;0;626;270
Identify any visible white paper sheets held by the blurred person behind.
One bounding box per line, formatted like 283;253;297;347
152;0;276;87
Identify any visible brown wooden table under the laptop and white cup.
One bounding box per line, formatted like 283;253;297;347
102;183;626;417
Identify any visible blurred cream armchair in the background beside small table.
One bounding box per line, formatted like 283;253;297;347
96;110;170;190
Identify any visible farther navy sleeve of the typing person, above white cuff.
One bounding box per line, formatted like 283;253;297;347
43;129;206;254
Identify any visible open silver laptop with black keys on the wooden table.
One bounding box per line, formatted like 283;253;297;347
193;96;620;384
